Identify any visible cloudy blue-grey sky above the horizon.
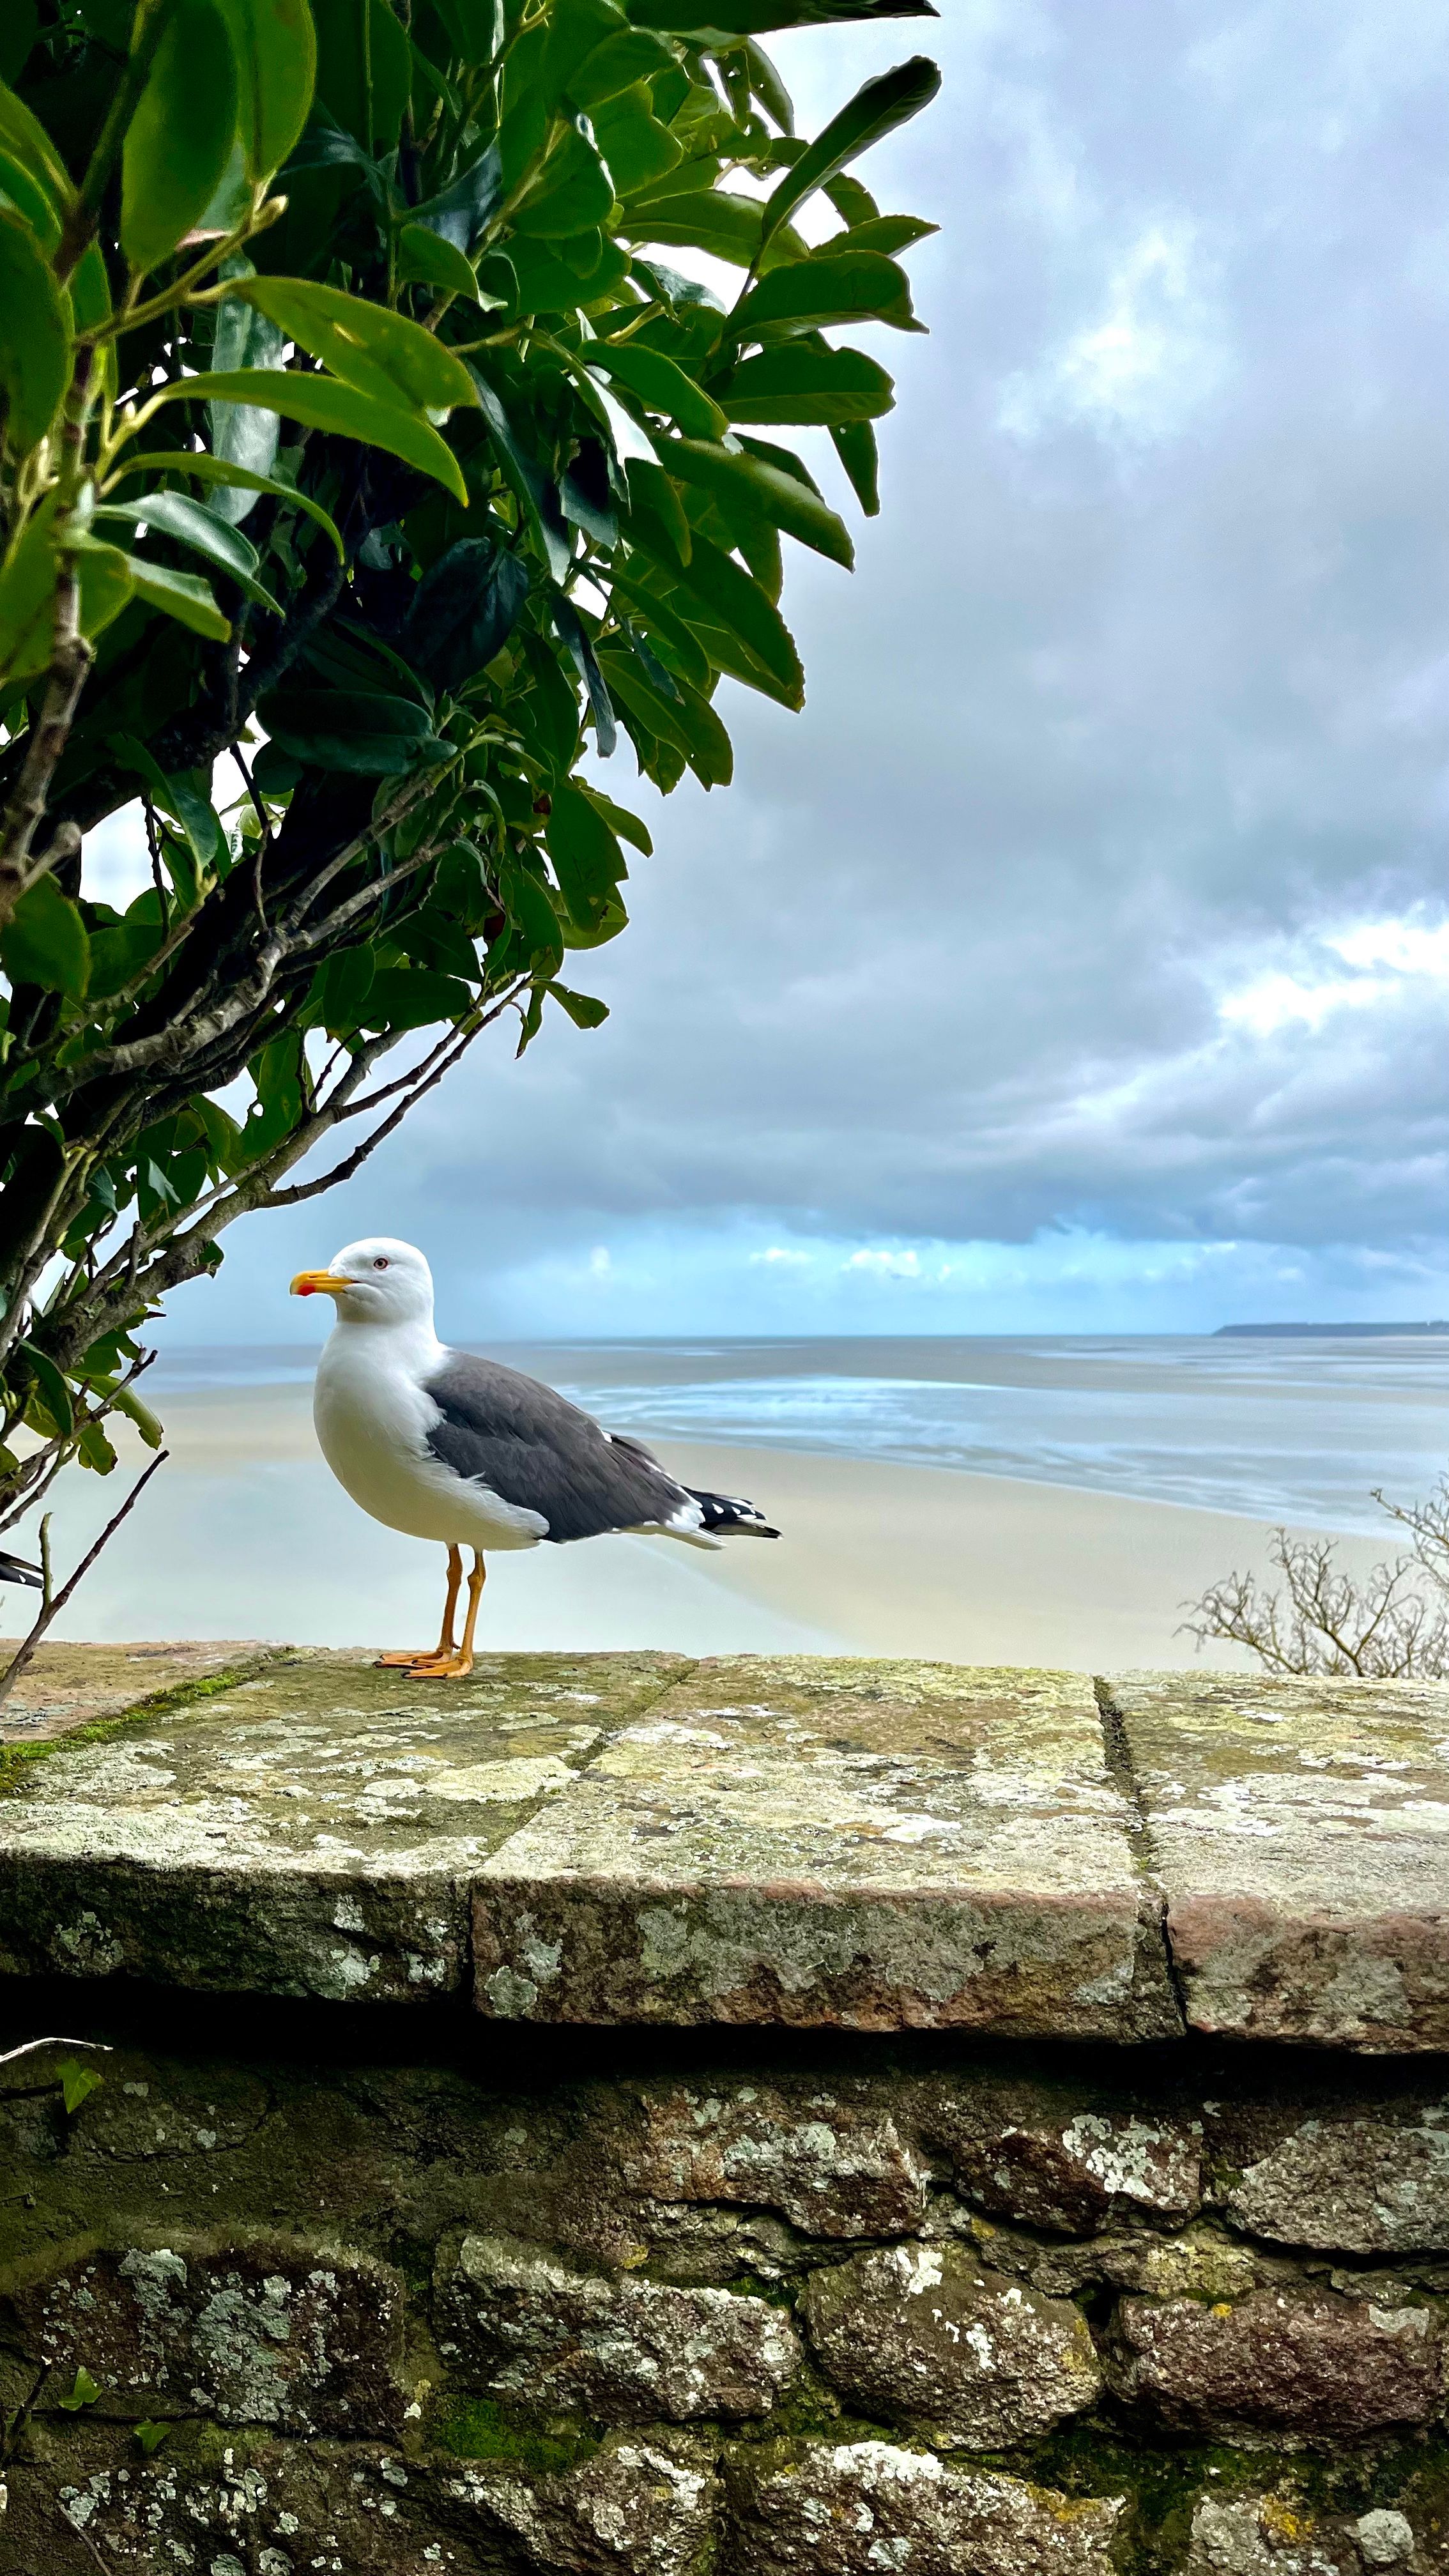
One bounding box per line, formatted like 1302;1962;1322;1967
90;0;1449;1342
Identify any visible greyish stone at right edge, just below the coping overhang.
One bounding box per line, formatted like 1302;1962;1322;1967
1225;2104;1449;2254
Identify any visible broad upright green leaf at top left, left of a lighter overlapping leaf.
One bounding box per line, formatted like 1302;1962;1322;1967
121;0;237;275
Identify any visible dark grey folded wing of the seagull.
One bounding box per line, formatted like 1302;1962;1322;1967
425;1350;704;1540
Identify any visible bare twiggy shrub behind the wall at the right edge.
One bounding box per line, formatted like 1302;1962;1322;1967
1183;1476;1449;1682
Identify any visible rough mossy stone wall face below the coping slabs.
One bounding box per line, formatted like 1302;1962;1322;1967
0;2002;1449;2576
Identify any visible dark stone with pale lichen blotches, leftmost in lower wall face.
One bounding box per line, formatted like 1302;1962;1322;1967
15;2239;405;2434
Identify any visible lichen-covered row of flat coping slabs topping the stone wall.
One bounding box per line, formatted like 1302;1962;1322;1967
0;1646;1449;2053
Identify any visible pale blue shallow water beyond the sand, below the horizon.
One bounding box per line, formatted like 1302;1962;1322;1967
150;1335;1449;1535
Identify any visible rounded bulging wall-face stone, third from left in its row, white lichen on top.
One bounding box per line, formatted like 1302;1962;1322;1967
802;2244;1101;2450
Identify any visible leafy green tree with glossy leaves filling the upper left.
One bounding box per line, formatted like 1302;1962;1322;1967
0;0;939;1597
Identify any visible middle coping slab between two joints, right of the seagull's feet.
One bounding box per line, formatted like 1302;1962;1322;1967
475;1657;1181;2040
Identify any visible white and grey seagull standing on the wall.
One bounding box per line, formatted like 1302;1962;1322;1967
291;1234;779;1682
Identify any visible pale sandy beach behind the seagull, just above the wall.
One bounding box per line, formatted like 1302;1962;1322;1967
8;1386;1384;1672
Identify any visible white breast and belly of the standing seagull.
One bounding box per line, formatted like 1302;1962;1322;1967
312;1321;549;1548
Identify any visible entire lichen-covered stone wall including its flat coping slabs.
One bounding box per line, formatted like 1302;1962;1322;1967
0;1657;1449;2576
